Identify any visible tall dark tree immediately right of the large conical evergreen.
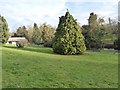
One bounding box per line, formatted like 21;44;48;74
82;13;105;50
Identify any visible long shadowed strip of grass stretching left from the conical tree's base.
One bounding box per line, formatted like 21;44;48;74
3;46;54;54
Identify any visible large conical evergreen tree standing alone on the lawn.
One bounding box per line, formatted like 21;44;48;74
53;11;86;55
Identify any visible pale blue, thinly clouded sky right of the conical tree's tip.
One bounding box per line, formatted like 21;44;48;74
64;1;118;25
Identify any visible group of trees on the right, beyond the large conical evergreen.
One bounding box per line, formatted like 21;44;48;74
82;12;118;50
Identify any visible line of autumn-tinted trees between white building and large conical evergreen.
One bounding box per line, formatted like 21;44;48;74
12;23;56;45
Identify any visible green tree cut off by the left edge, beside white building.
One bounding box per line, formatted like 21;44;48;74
0;16;9;44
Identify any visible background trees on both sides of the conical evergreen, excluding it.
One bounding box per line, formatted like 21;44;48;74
0;12;118;49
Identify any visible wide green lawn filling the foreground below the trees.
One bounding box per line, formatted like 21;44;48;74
2;46;118;88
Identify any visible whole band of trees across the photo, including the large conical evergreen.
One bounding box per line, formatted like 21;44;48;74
0;11;120;54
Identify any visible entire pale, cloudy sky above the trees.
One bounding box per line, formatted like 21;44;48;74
0;0;118;31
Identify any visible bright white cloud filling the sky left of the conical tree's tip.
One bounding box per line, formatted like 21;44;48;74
0;0;65;29
